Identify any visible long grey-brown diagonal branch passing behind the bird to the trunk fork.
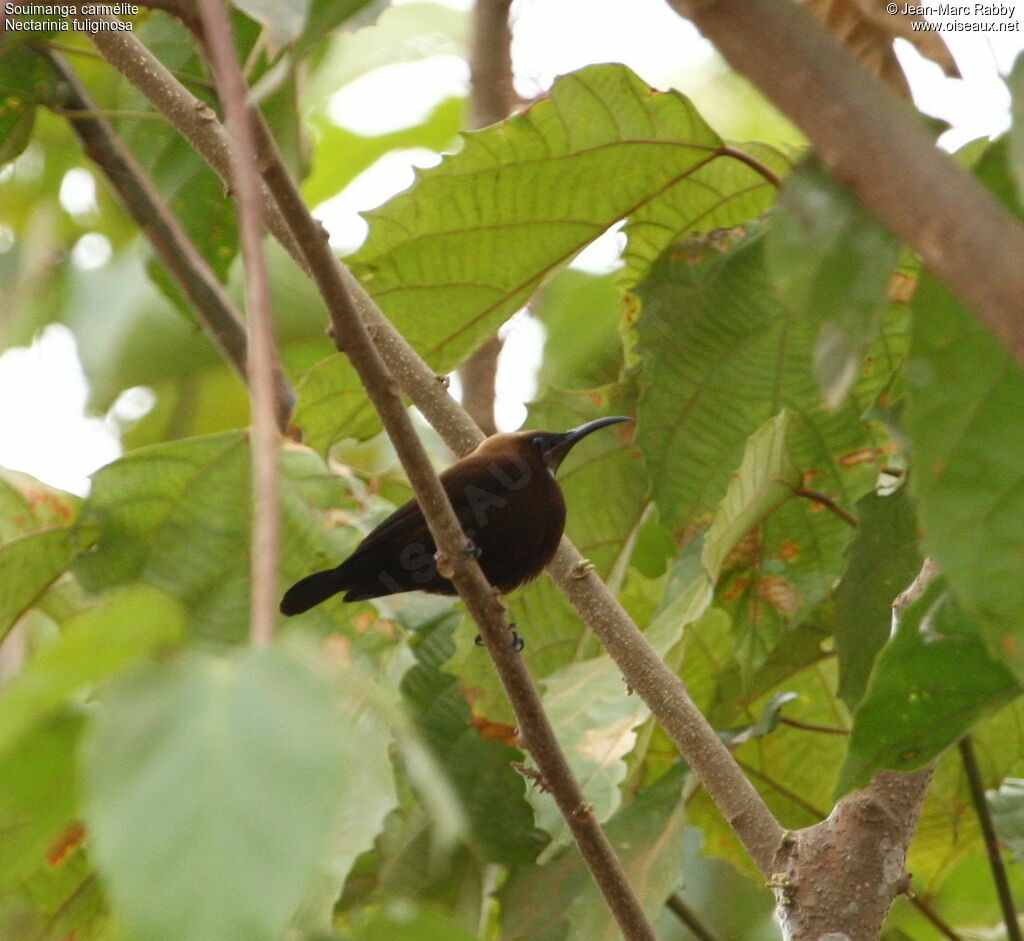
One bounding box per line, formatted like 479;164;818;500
77;17;783;876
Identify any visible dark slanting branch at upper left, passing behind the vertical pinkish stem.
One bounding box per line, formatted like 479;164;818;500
39;49;295;428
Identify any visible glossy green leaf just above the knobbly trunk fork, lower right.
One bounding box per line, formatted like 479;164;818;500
836;579;1021;795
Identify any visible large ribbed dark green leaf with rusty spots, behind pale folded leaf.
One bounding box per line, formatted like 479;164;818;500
637;236;881;673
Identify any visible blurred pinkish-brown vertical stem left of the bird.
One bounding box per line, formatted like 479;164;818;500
193;0;281;647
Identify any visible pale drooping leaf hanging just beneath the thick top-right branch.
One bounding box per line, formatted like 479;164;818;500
765;163;899;407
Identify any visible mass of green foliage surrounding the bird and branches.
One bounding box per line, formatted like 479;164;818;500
0;3;1024;939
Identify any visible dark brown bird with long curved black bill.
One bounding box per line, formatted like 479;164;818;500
281;417;630;615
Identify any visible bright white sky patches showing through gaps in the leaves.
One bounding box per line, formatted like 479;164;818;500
0;0;1024;494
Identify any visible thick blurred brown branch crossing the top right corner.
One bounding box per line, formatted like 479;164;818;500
667;0;1024;363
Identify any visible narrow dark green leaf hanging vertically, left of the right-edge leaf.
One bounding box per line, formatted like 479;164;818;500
835;486;922;710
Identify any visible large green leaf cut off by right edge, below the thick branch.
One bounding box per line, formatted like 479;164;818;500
906;276;1024;676
